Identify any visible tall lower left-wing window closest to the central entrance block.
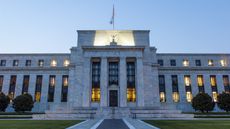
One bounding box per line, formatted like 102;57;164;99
61;75;69;102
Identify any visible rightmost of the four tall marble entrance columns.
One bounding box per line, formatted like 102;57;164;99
136;58;144;107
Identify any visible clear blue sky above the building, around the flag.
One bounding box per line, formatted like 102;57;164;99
0;0;230;53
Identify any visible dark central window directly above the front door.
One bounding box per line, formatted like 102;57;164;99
109;62;118;85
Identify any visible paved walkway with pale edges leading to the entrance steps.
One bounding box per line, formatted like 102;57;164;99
67;119;159;129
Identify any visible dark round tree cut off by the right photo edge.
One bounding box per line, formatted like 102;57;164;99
217;92;230;112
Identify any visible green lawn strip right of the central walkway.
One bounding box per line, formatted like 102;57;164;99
145;120;230;129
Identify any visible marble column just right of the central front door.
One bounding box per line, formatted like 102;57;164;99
119;57;127;107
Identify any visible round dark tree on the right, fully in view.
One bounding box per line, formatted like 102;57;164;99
192;93;215;113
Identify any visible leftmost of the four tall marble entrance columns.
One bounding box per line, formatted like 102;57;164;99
82;58;91;107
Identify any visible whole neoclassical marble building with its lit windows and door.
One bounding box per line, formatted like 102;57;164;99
0;30;230;117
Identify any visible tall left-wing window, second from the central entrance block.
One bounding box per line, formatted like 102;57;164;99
48;75;56;102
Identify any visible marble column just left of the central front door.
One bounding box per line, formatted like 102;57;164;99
100;57;108;107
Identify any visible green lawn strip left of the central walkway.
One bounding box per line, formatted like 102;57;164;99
0;120;81;129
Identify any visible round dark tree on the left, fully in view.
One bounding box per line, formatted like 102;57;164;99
13;94;34;112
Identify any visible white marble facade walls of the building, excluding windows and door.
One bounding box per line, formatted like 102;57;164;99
0;30;230;112
